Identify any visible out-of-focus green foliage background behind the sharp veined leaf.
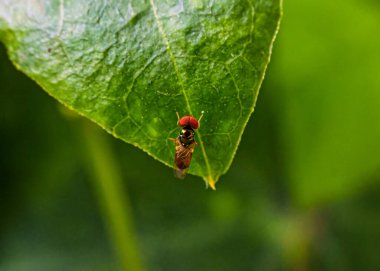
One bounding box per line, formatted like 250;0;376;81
0;0;380;271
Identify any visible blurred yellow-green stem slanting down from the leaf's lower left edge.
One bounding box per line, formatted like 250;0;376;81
84;123;143;271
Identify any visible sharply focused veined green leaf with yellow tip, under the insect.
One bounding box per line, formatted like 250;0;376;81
0;0;281;187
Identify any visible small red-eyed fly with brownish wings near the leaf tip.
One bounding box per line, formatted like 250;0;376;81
171;112;203;179
